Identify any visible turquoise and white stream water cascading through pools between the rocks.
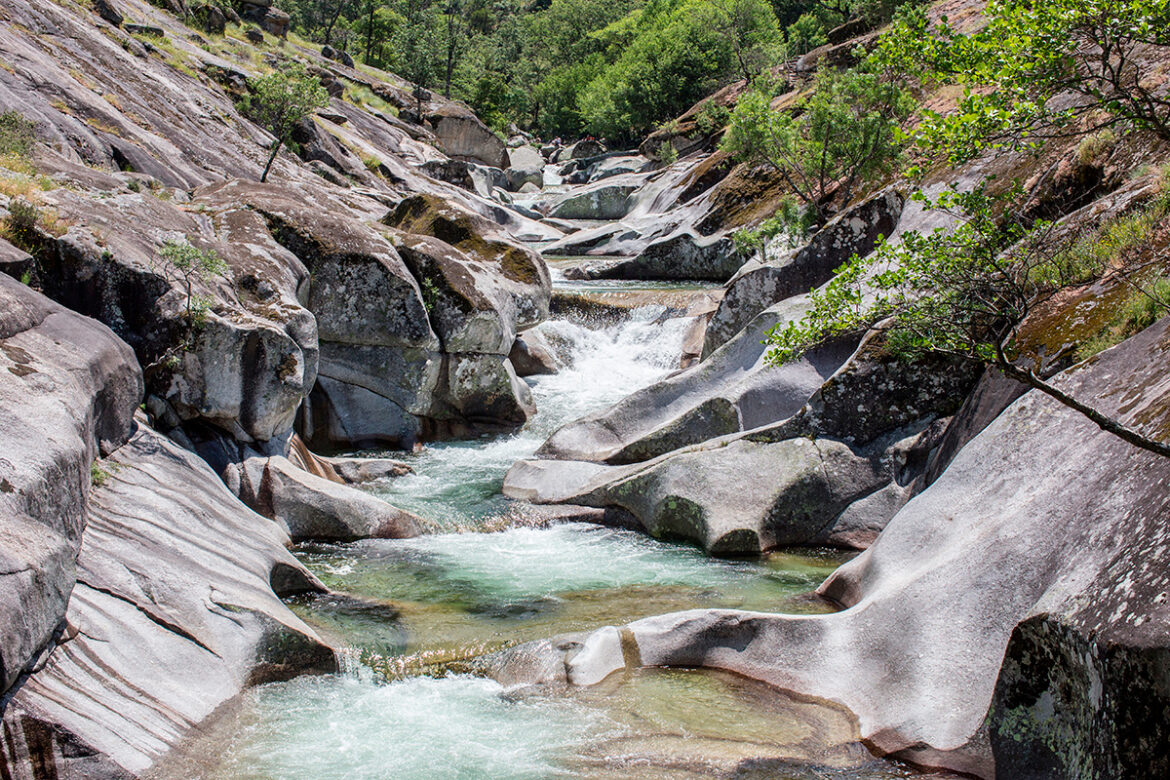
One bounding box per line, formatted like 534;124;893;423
194;260;940;780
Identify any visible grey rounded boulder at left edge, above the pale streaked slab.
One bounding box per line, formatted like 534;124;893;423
0;275;143;693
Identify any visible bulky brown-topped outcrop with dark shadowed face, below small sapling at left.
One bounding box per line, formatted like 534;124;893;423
30;178;317;441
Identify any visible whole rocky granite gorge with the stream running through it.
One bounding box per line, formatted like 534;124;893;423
0;0;1170;780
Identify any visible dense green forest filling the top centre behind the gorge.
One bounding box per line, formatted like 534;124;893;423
281;0;917;141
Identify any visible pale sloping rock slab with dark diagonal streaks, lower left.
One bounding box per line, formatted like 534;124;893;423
0;427;337;778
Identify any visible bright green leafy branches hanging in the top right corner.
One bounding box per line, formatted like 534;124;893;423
878;0;1170;164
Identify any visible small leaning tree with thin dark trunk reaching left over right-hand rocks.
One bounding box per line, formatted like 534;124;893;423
769;187;1170;456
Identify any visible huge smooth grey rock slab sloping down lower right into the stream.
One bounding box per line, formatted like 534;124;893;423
496;313;1170;778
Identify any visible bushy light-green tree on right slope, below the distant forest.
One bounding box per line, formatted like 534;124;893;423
723;68;914;223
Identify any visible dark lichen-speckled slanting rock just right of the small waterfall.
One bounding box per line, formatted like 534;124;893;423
703;191;904;357
